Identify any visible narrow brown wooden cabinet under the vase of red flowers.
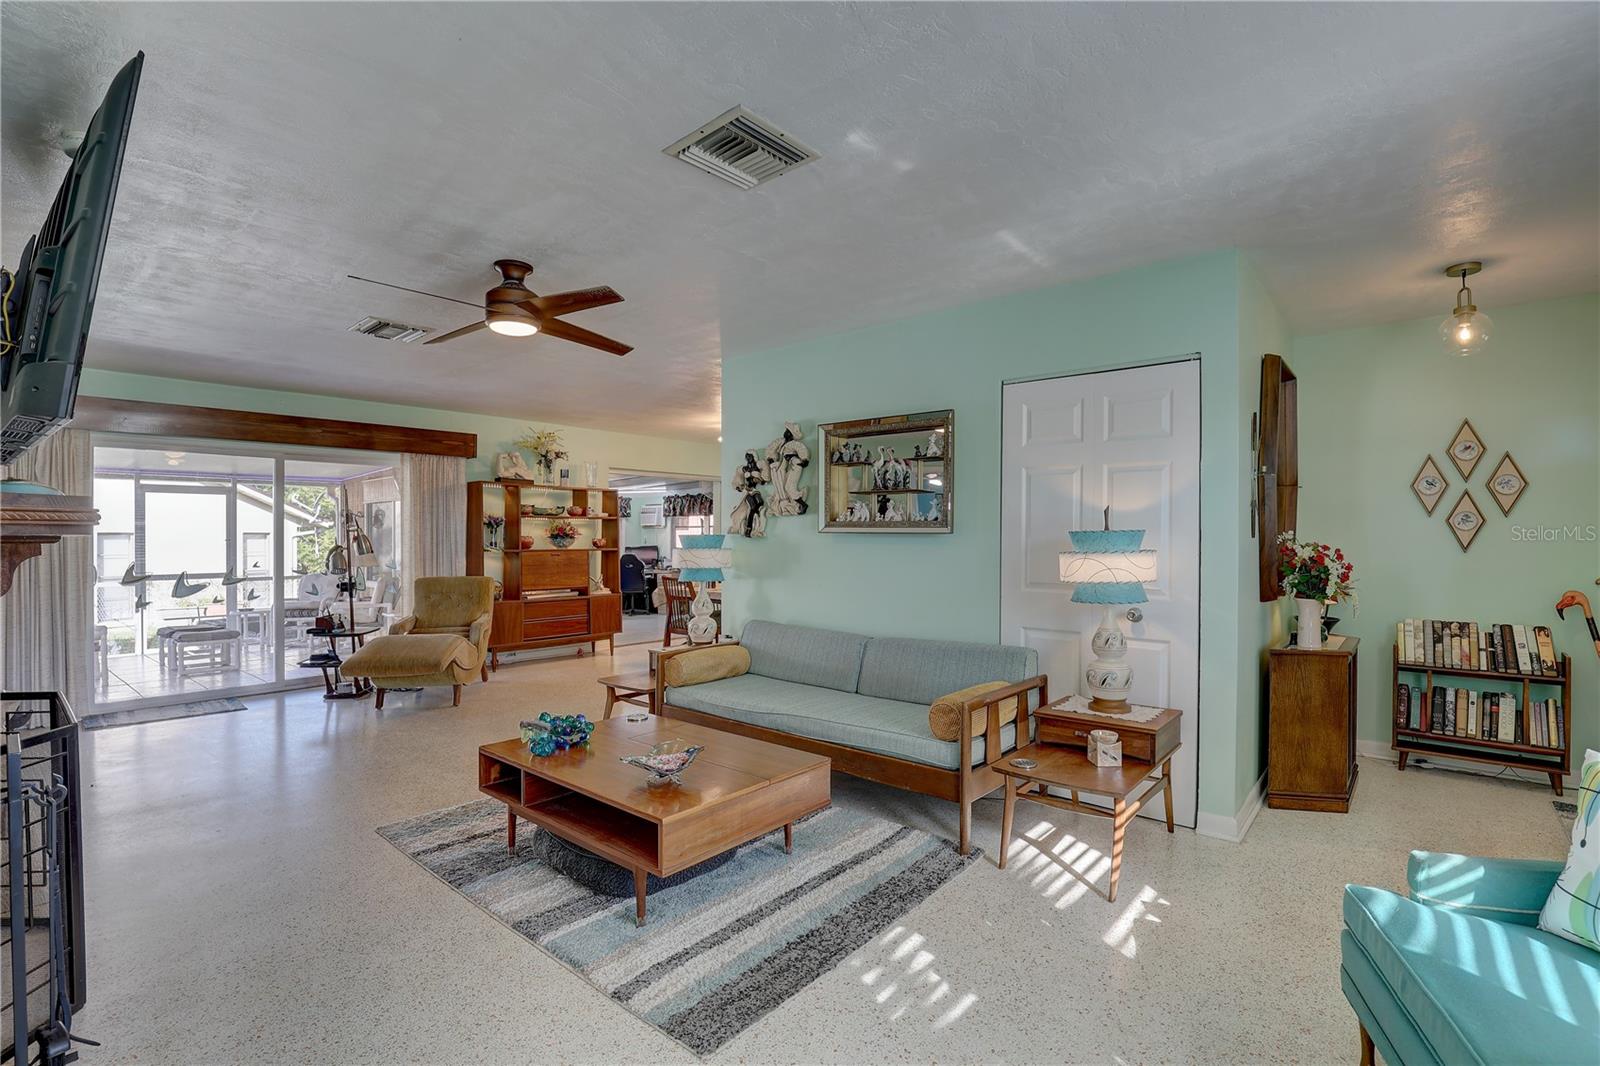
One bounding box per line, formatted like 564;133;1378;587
1267;637;1360;812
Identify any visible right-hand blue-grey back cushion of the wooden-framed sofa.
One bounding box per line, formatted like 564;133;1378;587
856;637;1038;704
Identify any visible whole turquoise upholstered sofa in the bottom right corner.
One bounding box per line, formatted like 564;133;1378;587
1339;852;1600;1066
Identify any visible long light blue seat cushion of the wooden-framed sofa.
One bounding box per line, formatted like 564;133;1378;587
666;672;1016;770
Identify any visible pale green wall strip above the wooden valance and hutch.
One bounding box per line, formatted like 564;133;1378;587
80;368;718;483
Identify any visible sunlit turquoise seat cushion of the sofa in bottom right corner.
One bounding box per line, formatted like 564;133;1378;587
1344;885;1600;1064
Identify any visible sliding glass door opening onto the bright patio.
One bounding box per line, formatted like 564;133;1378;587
94;434;400;706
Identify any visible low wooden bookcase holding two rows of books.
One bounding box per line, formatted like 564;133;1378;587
1389;647;1573;795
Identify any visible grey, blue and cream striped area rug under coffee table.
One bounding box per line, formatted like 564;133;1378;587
378;799;981;1055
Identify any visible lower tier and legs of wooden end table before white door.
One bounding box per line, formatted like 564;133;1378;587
989;744;1182;901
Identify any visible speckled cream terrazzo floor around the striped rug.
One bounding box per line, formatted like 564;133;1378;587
75;647;1565;1066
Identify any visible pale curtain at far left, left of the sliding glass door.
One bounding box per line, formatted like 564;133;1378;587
0;429;94;711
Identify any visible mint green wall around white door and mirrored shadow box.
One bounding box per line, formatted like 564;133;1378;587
722;251;1259;816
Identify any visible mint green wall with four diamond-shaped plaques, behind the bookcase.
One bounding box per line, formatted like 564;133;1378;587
1291;287;1600;768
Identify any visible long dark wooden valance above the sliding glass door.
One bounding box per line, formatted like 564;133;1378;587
72;395;478;459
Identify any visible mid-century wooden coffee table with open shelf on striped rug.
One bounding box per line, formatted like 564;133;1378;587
478;715;830;925
